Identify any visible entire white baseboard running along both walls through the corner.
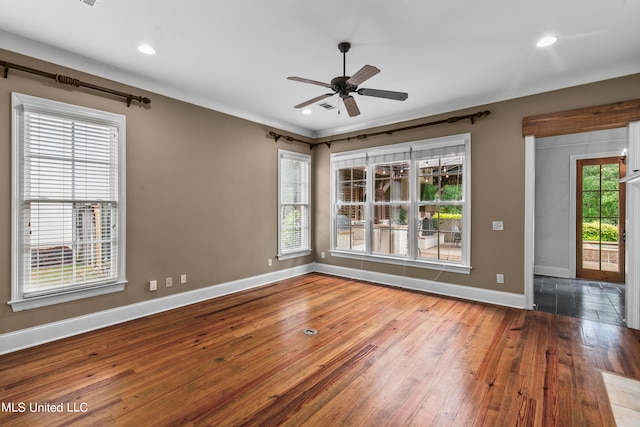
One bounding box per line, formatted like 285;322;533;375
0;263;525;354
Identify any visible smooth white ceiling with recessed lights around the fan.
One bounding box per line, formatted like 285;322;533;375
0;0;640;136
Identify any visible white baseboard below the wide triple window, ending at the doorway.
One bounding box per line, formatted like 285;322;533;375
315;264;525;308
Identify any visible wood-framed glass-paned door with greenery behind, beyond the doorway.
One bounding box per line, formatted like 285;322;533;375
576;157;625;283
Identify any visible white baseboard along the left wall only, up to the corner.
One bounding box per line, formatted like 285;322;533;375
0;264;314;354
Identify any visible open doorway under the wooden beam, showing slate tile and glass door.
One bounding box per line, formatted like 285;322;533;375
529;128;629;326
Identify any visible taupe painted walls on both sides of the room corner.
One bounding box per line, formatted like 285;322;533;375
0;46;640;334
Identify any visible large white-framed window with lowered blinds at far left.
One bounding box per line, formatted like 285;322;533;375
10;93;125;311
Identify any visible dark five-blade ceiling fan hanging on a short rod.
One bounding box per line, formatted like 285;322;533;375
287;42;409;117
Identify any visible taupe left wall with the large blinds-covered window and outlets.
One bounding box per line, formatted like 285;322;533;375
0;50;312;334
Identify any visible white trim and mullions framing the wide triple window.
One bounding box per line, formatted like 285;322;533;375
329;133;472;274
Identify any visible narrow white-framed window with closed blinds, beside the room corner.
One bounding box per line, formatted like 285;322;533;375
278;150;311;259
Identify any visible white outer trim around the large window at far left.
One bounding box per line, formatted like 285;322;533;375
8;92;127;311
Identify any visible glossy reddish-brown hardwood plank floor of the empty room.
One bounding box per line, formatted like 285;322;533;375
0;274;640;426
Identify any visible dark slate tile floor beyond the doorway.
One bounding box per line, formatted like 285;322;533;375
533;275;626;326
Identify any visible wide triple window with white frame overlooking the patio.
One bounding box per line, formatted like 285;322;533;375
331;134;471;273
